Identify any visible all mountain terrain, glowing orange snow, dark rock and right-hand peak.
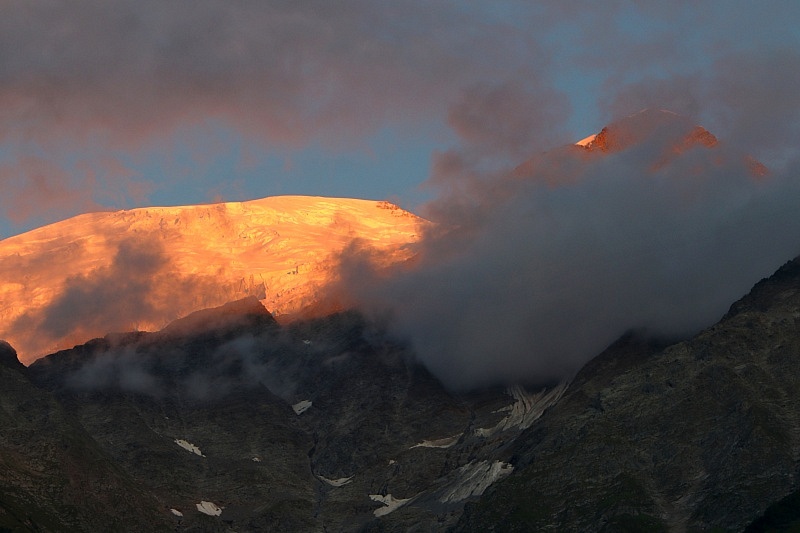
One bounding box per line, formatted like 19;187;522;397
0;111;800;532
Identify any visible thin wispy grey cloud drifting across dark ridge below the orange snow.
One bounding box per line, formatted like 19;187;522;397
61;317;306;402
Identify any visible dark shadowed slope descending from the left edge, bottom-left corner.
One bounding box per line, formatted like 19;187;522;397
0;342;172;532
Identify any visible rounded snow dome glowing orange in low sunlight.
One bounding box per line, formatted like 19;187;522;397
0;196;427;364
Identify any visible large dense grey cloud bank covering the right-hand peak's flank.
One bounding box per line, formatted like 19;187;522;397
338;109;800;388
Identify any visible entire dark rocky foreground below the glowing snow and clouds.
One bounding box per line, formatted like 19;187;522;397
0;261;800;532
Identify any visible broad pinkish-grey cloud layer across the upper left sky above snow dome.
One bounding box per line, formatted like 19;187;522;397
0;0;564;227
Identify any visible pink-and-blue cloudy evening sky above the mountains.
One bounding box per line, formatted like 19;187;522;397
0;0;800;238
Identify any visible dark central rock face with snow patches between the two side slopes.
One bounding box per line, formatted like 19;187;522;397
27;300;563;531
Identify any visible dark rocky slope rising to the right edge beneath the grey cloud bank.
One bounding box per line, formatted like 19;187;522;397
456;260;800;531
